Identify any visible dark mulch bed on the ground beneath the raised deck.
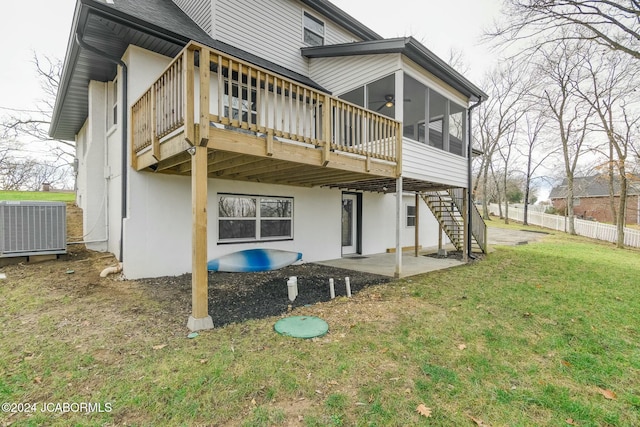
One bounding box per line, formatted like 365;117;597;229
139;263;392;327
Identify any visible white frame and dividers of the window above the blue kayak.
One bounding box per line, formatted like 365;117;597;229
217;193;294;243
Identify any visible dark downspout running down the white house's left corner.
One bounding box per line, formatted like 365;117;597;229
75;31;129;263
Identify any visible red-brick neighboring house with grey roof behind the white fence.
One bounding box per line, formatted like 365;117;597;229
549;175;640;224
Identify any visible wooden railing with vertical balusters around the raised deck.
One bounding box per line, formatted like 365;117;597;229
132;42;402;164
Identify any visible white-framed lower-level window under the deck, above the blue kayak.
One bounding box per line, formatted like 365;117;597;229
218;194;293;243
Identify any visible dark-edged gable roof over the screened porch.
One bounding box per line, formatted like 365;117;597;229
301;37;489;102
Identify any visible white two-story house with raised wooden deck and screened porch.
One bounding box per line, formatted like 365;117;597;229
50;0;487;329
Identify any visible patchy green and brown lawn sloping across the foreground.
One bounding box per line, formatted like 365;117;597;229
0;229;640;426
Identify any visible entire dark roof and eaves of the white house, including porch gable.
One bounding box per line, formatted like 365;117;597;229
49;0;488;140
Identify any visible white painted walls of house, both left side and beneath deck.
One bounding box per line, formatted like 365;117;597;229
78;47;460;279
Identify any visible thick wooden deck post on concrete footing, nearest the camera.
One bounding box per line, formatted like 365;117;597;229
187;145;213;331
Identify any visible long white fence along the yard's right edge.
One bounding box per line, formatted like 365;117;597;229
489;203;640;248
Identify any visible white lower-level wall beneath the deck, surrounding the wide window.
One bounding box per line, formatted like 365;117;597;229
124;172;444;279
